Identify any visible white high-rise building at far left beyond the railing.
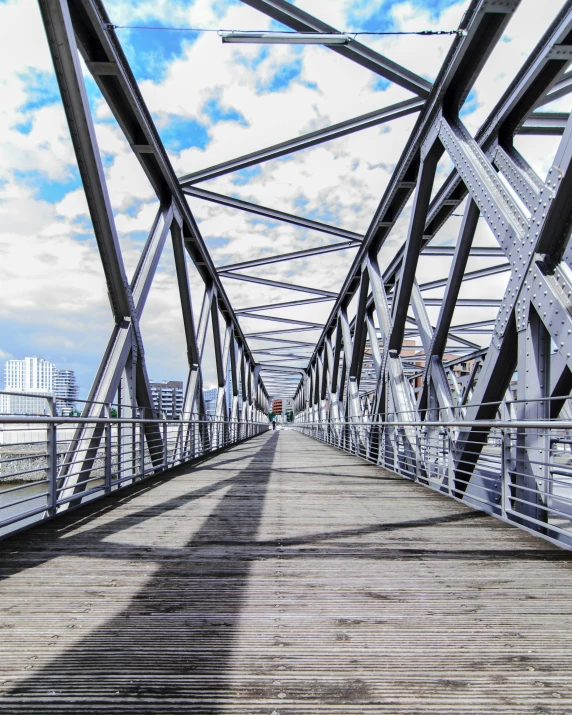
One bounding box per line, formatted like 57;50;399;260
0;357;56;415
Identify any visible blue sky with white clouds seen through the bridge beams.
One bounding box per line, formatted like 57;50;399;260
0;0;562;396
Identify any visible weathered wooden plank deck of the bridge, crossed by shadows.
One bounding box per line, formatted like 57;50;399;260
0;432;572;715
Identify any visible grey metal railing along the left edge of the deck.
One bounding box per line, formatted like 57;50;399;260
0;415;269;537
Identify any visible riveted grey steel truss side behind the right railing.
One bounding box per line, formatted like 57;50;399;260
286;2;572;548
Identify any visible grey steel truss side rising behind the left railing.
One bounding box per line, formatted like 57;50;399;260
40;0;268;509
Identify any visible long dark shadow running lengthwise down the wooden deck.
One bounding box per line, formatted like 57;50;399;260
0;434;278;715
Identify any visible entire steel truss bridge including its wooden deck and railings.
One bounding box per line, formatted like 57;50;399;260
5;0;572;715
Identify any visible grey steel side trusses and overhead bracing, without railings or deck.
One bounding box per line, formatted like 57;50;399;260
39;0;572;536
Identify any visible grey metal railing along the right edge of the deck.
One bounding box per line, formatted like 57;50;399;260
298;419;572;550
